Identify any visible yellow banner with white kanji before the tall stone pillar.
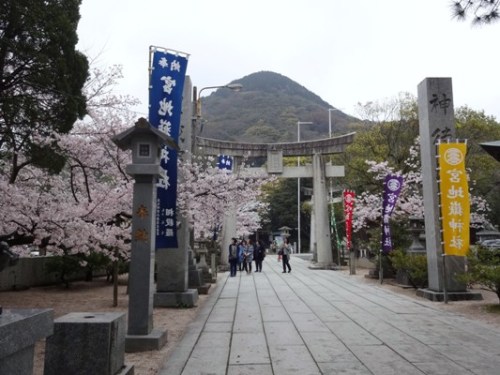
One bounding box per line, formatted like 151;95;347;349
438;143;470;256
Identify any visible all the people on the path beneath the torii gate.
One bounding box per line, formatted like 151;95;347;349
228;238;293;277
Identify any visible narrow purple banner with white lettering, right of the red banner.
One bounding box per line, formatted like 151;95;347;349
382;174;403;253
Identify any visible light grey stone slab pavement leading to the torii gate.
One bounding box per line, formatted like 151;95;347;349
160;255;500;375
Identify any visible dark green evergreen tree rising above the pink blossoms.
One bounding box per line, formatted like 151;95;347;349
0;0;88;183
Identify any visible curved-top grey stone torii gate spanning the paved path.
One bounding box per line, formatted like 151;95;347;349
196;133;355;268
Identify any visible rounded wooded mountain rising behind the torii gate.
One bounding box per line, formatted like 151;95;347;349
201;71;360;143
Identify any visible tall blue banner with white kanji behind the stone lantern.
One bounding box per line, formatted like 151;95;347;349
149;49;187;249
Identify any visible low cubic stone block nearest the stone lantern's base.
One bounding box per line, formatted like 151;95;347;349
44;312;134;375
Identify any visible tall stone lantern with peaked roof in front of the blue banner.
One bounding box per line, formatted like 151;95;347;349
113;118;178;352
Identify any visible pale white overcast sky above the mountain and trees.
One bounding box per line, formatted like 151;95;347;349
78;0;500;120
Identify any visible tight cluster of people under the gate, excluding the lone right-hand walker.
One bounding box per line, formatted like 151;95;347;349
229;238;266;276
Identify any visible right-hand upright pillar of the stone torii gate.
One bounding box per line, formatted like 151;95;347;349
313;152;333;268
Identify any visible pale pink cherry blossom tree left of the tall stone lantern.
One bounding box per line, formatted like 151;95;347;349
0;66;136;262
